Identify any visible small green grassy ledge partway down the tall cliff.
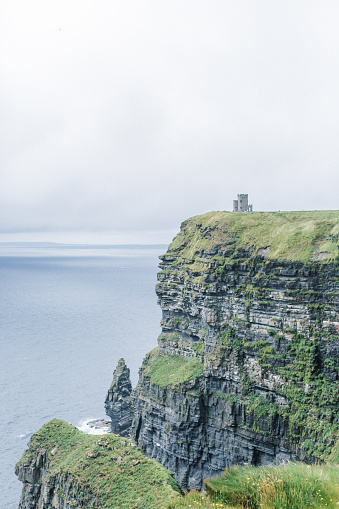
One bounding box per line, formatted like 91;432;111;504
143;350;204;388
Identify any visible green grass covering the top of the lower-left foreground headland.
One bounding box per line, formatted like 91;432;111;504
19;419;181;509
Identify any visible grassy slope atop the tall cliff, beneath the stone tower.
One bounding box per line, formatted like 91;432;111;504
167;210;339;263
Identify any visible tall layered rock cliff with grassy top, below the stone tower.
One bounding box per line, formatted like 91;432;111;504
107;212;339;488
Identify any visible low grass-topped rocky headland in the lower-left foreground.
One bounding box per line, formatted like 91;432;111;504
15;419;182;509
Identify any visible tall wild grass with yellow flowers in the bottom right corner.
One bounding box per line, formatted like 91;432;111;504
169;463;339;509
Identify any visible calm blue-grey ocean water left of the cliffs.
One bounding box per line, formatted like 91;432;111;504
0;244;166;509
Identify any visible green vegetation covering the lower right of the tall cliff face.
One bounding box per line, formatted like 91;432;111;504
216;329;339;460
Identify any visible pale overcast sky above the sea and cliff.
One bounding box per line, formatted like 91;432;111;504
0;0;339;243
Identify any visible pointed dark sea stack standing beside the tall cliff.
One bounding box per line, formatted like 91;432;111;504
105;359;132;436
